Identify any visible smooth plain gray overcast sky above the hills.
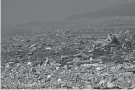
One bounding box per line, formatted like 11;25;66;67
1;0;127;25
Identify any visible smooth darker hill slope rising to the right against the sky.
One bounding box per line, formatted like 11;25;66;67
66;2;135;20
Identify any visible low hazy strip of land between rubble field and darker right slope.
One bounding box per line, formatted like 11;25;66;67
1;16;135;37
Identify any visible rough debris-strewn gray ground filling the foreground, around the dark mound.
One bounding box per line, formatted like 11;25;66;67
1;17;135;89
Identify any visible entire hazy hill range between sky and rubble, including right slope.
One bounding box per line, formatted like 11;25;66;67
1;2;135;37
